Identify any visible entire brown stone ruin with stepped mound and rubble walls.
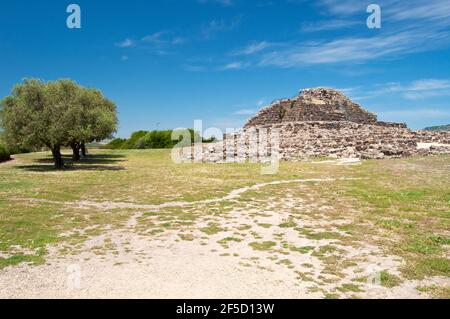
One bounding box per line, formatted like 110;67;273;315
185;88;450;162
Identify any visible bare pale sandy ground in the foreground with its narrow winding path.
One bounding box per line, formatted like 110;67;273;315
0;180;450;299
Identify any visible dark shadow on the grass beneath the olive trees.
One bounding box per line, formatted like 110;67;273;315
17;154;125;172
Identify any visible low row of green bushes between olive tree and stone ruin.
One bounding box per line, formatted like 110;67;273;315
104;129;215;149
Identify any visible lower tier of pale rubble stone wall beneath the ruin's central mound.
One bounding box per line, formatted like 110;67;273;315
185;121;426;162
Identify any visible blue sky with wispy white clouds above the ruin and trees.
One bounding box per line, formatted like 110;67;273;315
0;0;450;137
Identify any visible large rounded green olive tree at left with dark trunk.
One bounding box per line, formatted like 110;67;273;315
0;79;117;169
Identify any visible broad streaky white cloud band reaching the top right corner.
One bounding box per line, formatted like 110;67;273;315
224;0;450;68
